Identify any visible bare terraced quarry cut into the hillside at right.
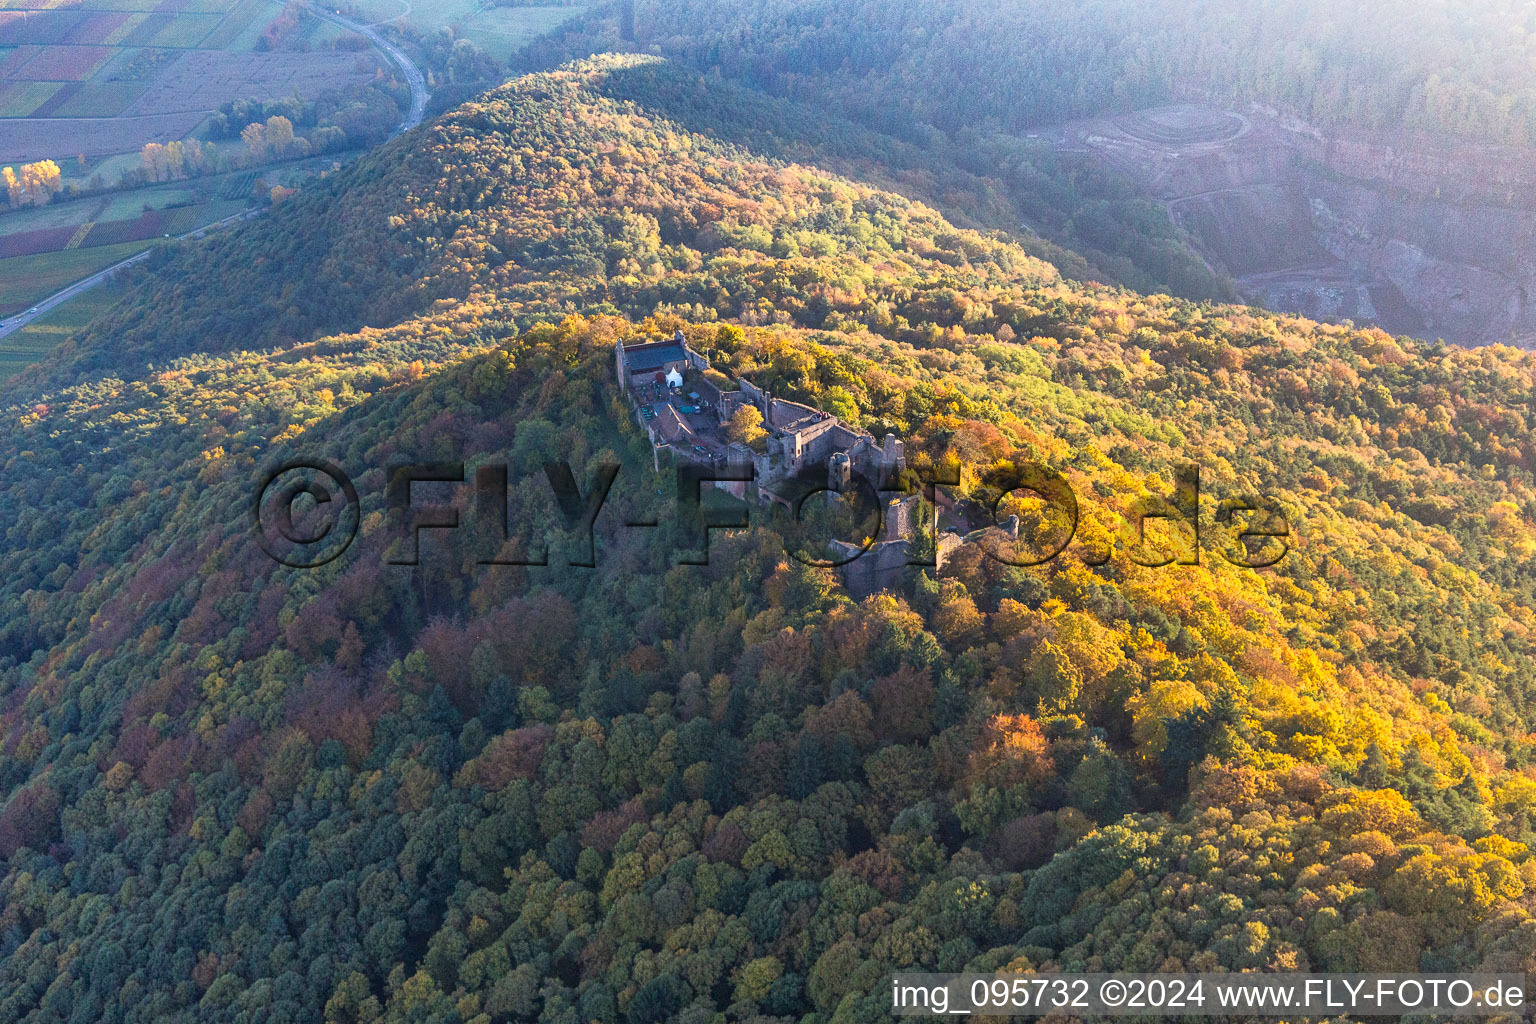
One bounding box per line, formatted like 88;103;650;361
1057;104;1536;347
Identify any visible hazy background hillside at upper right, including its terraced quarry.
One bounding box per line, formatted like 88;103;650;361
521;0;1536;337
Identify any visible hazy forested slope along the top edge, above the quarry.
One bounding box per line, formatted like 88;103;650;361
533;0;1536;146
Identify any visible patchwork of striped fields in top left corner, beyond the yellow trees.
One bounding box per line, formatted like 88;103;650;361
0;0;378;166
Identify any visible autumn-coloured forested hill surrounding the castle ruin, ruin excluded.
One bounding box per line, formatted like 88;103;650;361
0;57;1536;1024
